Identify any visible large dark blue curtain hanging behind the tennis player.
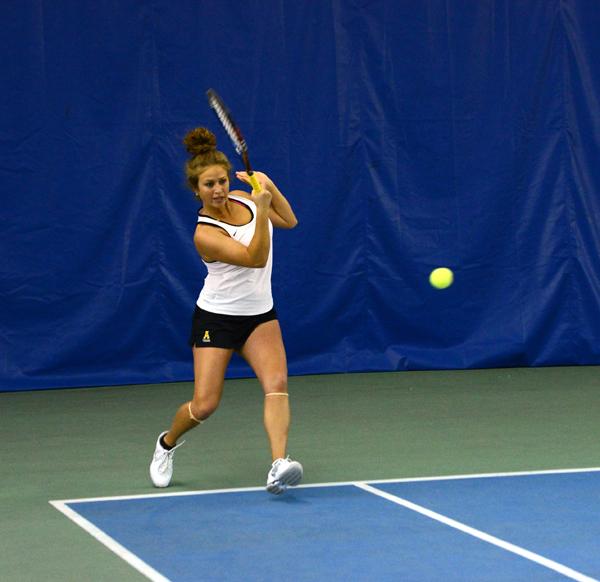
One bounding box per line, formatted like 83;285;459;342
0;0;600;390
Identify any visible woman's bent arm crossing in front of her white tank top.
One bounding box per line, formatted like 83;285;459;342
194;190;271;269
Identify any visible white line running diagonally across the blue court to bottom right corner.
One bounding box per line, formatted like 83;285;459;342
354;482;598;582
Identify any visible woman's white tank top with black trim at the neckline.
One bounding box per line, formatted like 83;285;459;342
196;195;273;315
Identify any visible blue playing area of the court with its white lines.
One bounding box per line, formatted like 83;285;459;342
52;469;600;581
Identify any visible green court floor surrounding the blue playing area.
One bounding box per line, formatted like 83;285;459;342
0;367;600;581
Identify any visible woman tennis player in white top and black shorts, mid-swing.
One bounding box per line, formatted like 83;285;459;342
150;128;303;494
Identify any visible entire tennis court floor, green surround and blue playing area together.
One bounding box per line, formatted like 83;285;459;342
0;367;600;582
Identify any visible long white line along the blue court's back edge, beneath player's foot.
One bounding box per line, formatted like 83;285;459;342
49;467;600;505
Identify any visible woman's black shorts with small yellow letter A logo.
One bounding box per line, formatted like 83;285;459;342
189;305;277;350
